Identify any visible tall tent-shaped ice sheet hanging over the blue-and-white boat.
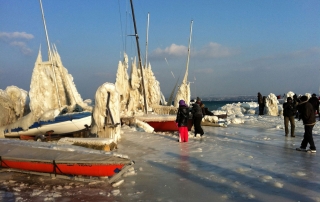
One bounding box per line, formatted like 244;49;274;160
29;48;91;119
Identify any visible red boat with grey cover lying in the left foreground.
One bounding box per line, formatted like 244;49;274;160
0;139;132;177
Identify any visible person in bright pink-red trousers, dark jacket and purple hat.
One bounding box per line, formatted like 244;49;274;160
176;100;189;142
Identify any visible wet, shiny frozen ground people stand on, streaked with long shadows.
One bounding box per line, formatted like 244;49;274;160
0;114;320;201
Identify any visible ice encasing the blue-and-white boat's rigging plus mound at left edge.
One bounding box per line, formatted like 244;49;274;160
0;47;92;137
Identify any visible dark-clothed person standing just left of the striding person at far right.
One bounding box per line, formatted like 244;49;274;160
283;97;297;137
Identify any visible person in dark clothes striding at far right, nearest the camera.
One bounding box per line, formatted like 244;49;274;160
297;95;316;153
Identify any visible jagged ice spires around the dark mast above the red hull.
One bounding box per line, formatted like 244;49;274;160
115;54;172;117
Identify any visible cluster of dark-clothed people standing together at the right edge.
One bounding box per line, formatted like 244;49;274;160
283;94;319;153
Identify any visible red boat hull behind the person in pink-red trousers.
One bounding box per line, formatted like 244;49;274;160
136;115;193;132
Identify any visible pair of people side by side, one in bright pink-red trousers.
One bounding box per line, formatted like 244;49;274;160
176;97;205;142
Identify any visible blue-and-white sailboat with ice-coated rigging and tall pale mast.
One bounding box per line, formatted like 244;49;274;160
0;1;92;137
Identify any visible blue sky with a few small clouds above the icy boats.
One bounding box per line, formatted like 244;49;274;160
0;0;320;99
